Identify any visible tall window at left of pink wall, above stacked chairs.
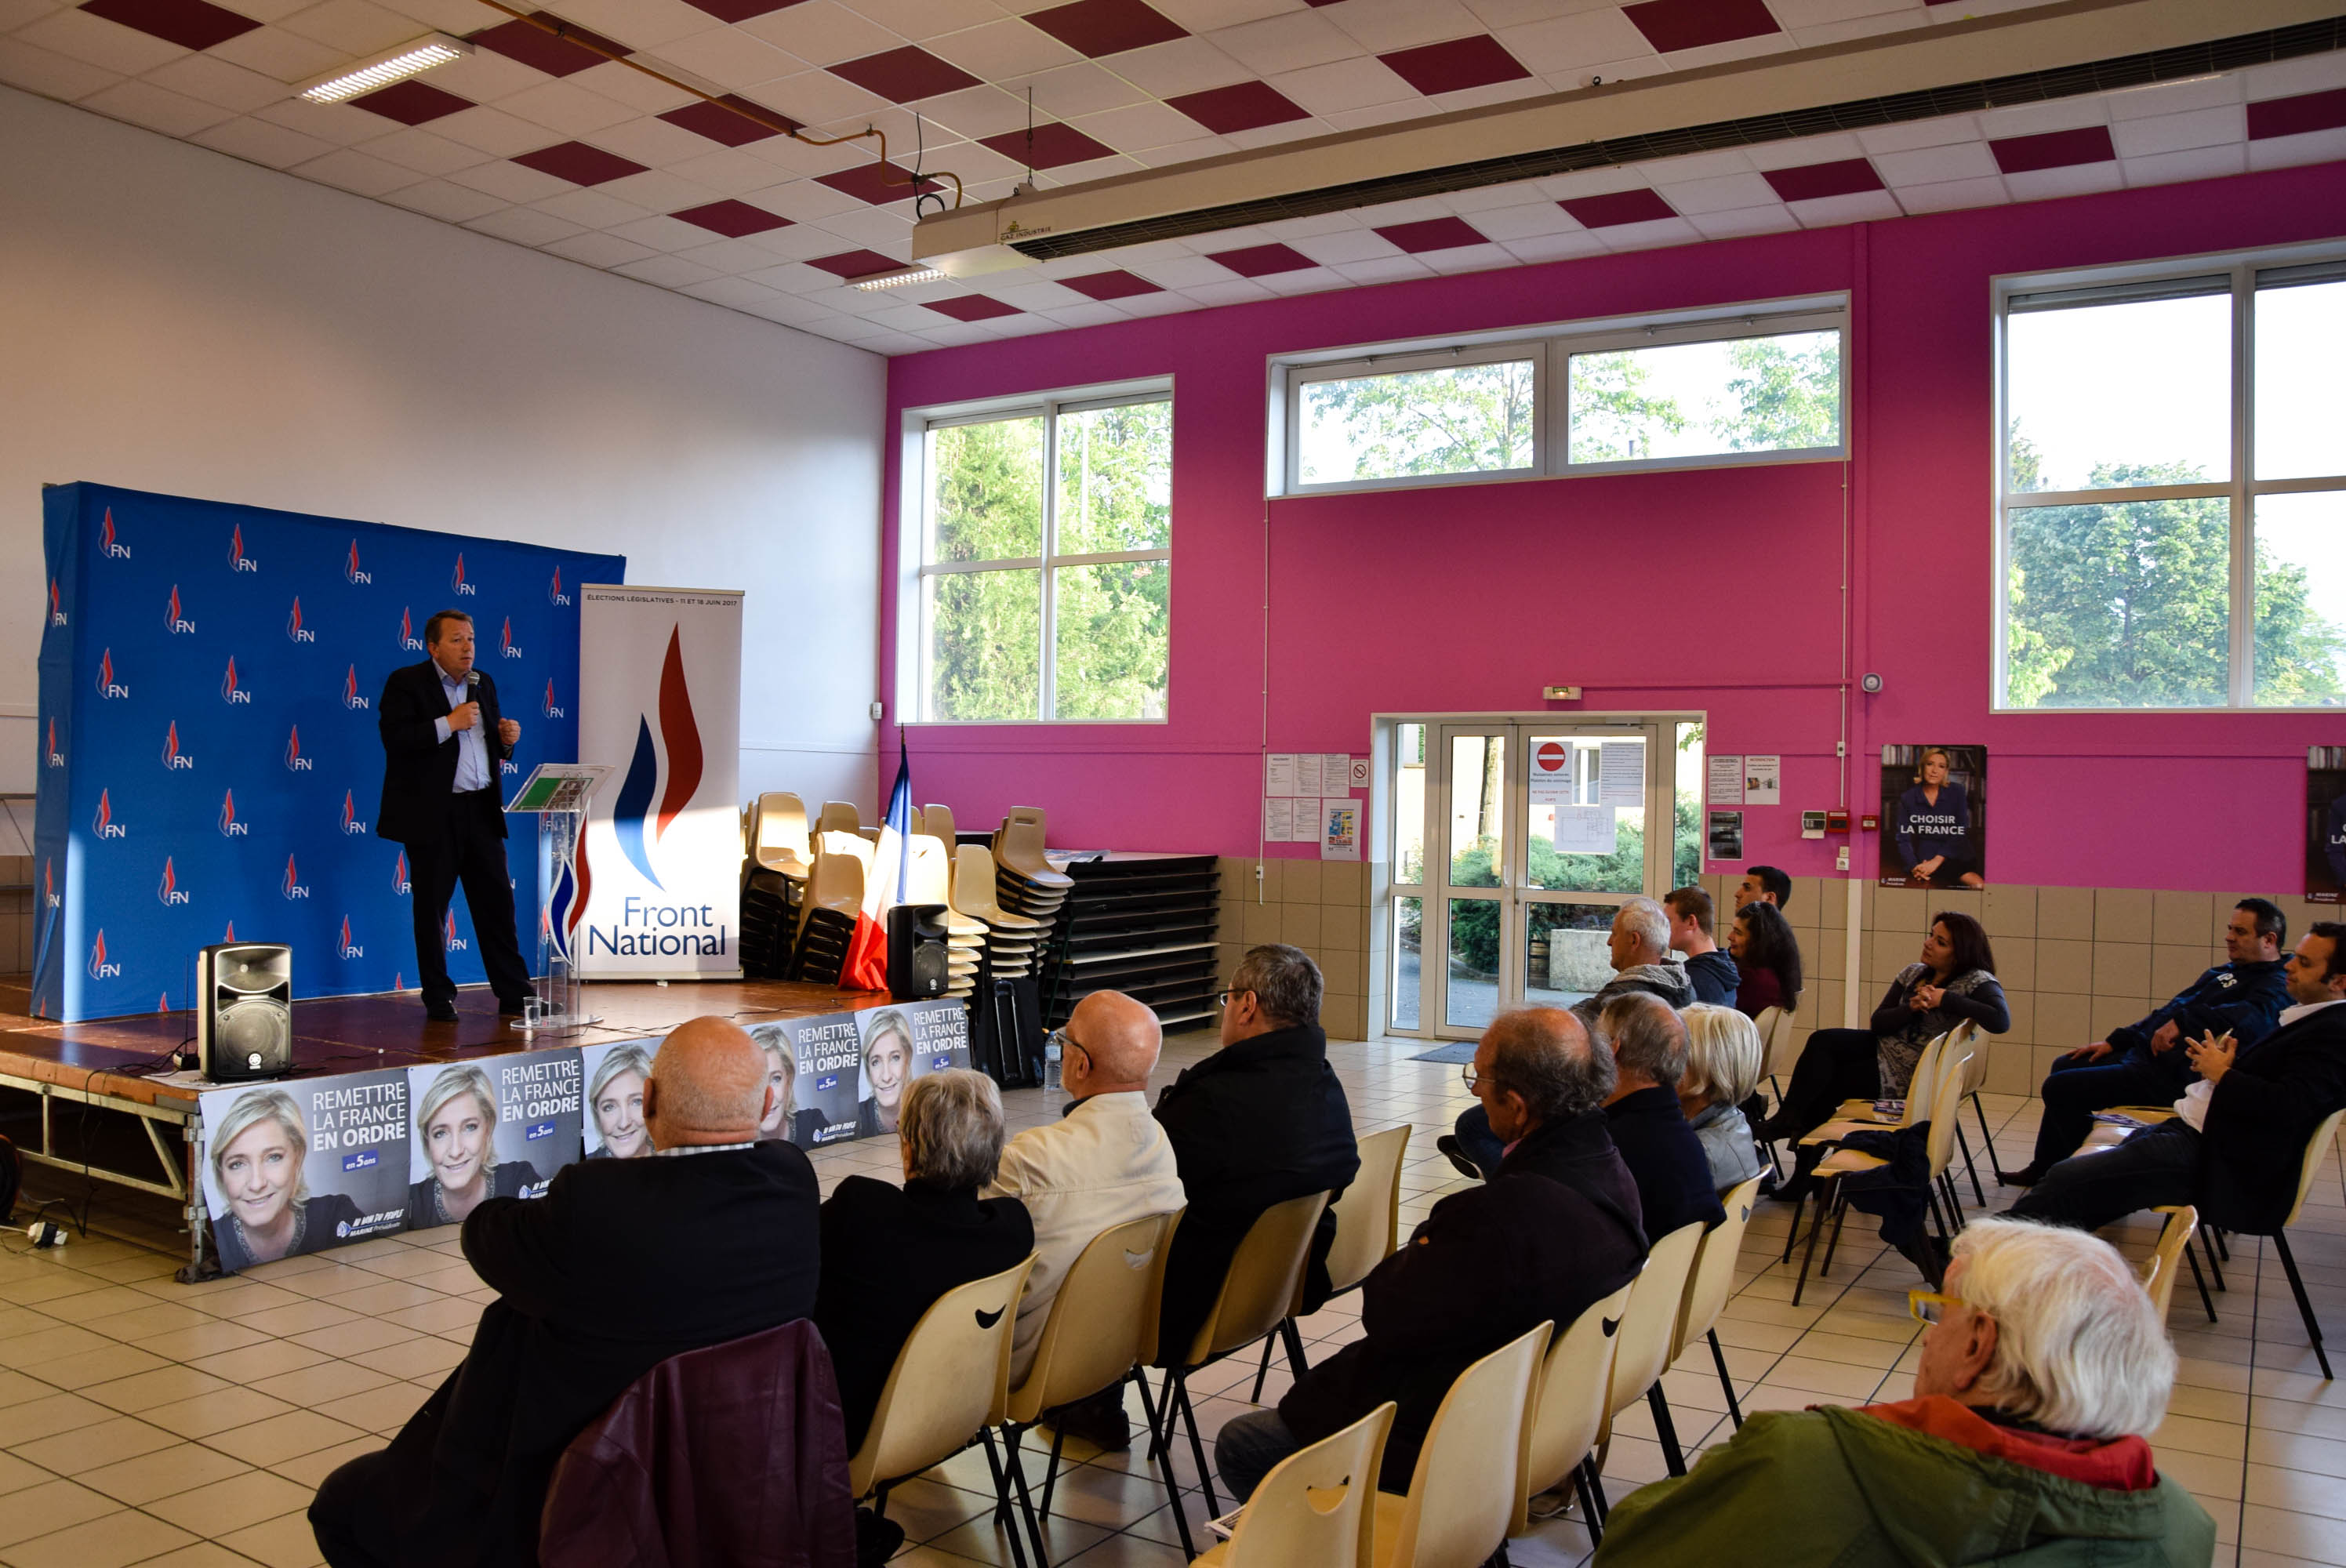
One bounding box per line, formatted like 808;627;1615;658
910;394;1173;723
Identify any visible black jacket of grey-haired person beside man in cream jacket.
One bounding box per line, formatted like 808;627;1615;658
814;1176;1034;1453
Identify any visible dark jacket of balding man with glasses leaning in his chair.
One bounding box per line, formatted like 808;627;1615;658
1276;1110;1644;1493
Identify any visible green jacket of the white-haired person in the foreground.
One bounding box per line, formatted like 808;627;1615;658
1596;1406;2214;1568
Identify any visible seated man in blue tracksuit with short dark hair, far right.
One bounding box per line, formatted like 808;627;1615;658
2003;899;2290;1188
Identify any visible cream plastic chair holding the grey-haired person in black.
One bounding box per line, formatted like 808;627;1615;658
847;1254;1034;1568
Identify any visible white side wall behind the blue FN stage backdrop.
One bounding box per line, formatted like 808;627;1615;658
0;87;887;812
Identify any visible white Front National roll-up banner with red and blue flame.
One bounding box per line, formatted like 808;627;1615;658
575;583;741;981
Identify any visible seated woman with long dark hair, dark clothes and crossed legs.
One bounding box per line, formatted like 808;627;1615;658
1755;911;2013;1200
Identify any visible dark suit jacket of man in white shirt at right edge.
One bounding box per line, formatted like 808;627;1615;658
2177;1002;2346;1235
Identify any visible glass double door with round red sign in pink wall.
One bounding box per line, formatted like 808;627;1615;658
1389;718;1701;1037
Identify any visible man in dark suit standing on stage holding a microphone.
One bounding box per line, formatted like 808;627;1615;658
376;610;530;1023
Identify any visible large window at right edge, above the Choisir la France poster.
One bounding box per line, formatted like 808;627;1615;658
1999;260;2346;709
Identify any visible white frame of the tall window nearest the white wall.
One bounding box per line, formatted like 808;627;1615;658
894;376;1173;725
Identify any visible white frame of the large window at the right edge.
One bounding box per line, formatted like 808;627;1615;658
1987;239;2346;716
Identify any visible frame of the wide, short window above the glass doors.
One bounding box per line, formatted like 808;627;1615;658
1265;293;1851;498
